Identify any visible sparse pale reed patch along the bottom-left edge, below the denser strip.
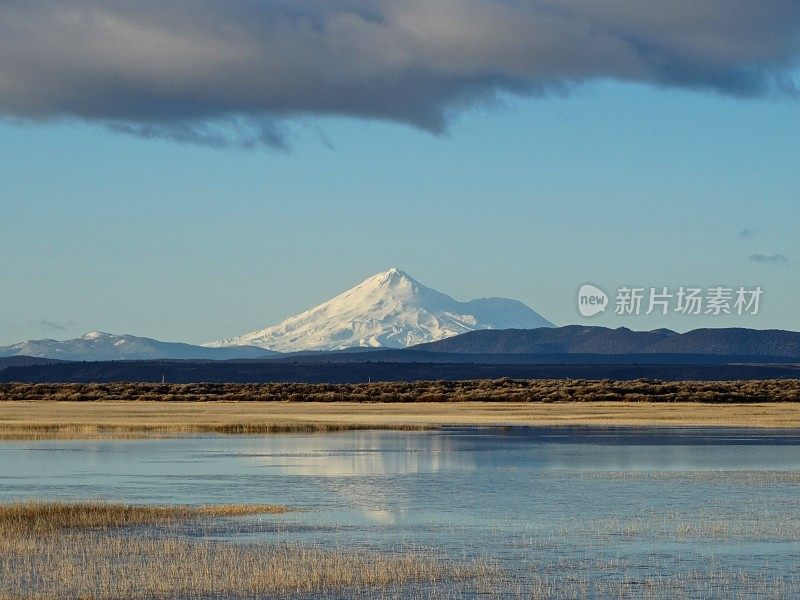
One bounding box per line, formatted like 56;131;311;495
0;534;490;600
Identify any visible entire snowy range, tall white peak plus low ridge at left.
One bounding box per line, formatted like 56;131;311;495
0;269;553;361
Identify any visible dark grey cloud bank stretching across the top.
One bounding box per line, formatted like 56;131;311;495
0;0;800;147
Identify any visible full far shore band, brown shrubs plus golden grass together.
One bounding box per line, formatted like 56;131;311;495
0;379;800;440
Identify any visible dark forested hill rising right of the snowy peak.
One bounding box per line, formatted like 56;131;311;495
409;325;800;360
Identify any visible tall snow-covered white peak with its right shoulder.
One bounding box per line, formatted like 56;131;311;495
206;268;553;352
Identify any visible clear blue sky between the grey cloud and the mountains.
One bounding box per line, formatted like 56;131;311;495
0;77;800;343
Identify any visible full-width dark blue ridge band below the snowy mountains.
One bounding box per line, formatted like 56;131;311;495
0;325;800;383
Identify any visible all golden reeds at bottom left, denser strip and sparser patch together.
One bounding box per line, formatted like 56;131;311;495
0;502;496;600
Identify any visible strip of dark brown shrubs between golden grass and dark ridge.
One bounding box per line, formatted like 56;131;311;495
0;378;800;403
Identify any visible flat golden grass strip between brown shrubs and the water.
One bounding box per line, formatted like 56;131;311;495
0;400;800;440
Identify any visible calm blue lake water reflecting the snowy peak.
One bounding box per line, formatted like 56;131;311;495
0;428;800;593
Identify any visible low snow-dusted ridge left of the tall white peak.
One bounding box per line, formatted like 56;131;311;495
0;331;274;360
